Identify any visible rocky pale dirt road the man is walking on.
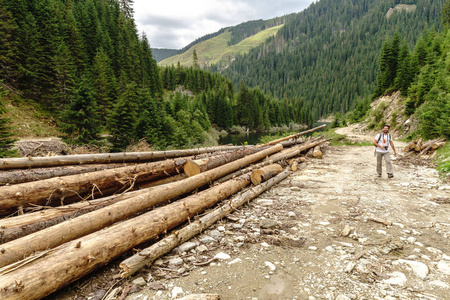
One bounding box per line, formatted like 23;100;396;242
121;128;450;300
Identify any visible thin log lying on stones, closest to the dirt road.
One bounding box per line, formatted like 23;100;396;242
119;171;289;278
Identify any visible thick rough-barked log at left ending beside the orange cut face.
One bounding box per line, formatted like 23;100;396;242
0;158;192;215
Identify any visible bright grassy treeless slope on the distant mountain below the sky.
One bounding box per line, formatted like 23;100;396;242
159;25;283;67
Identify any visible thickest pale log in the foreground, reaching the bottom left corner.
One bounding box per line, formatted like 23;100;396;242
0;171;260;300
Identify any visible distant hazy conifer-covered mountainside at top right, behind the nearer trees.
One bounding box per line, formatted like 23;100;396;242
217;0;444;118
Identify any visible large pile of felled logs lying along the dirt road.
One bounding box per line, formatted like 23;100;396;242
0;127;326;299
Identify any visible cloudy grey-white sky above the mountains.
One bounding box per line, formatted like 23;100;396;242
134;0;314;49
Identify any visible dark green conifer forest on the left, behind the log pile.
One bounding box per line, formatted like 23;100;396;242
0;0;313;155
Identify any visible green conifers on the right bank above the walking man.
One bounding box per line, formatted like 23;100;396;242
374;1;450;139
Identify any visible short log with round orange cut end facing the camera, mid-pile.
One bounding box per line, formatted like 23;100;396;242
183;147;264;176
